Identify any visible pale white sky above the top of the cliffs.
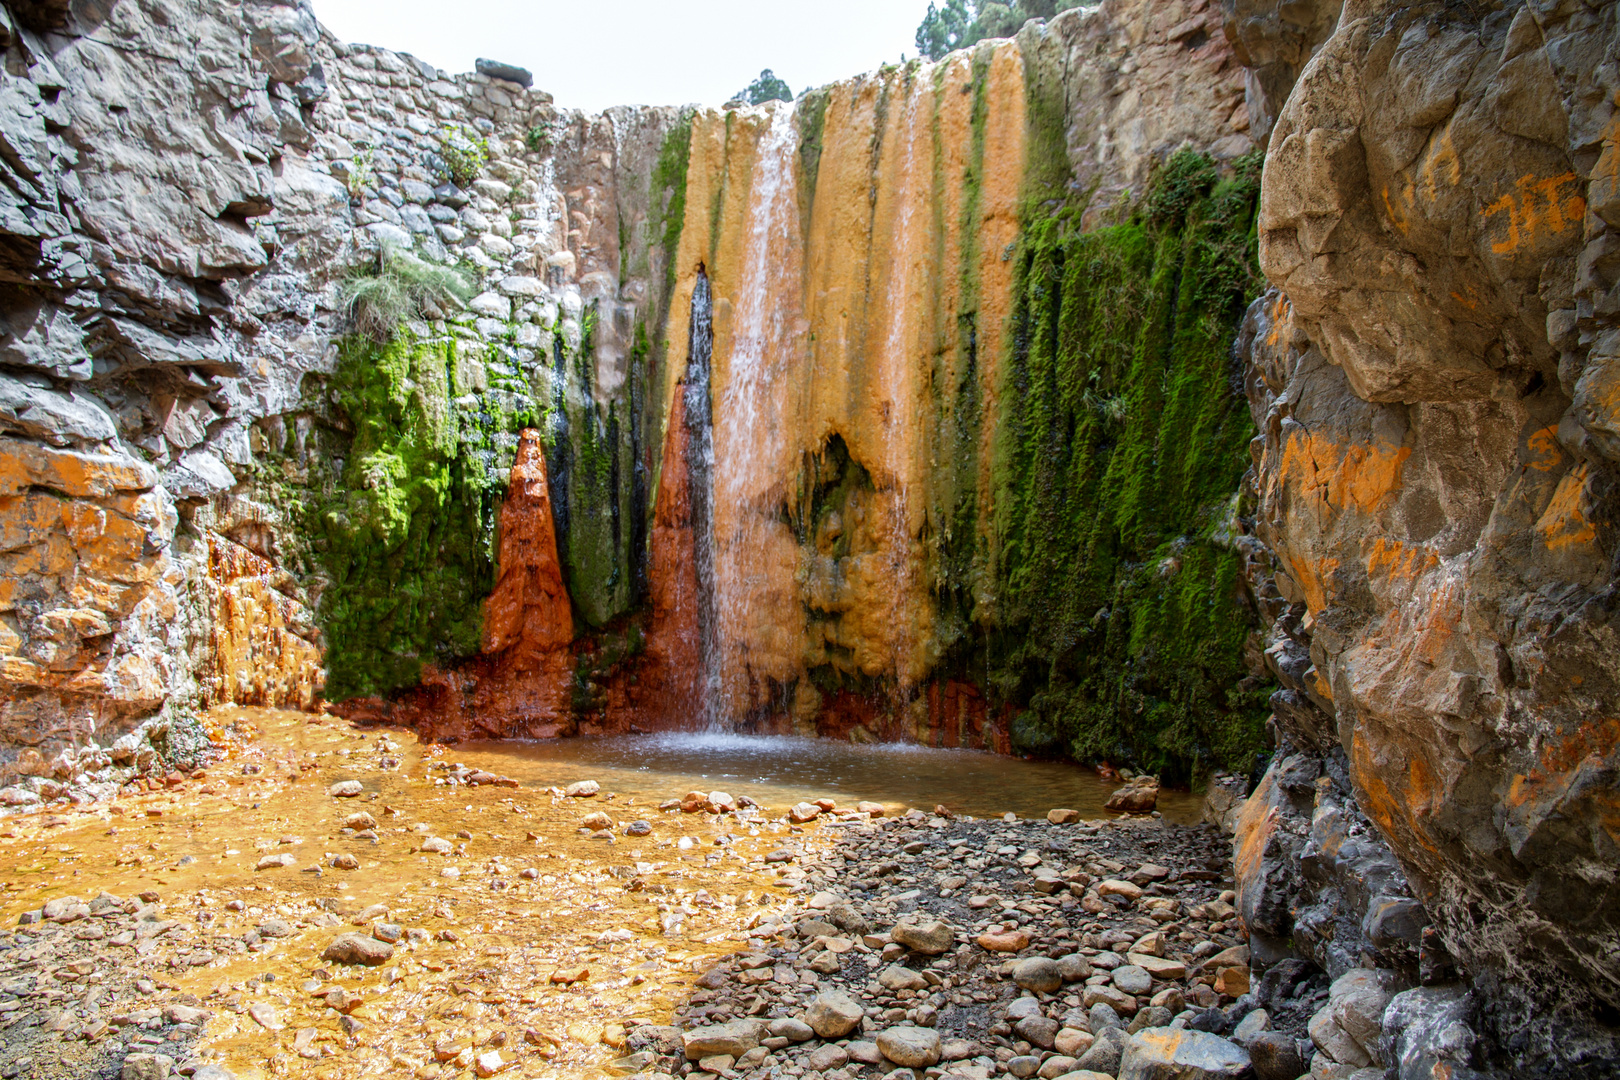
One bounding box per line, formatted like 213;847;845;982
313;0;928;112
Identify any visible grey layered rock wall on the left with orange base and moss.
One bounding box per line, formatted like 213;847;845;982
0;0;680;756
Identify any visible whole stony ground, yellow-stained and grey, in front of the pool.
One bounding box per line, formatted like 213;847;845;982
0;711;1354;1080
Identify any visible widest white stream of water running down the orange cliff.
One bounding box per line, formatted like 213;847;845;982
711;104;804;725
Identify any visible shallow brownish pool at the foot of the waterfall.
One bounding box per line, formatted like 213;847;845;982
446;732;1202;824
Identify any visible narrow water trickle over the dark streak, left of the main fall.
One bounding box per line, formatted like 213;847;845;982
682;269;721;729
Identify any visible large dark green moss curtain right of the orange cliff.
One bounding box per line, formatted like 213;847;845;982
987;149;1265;777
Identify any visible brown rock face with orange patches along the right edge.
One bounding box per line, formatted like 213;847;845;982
1228;3;1620;1075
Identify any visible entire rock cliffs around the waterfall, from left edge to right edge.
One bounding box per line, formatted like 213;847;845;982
0;0;1620;1075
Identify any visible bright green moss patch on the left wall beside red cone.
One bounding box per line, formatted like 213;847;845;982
305;334;505;699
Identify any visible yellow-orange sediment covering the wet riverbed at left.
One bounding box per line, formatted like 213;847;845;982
0;708;818;1080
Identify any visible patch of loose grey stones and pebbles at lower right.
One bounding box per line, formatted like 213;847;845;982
651;811;1327;1080
